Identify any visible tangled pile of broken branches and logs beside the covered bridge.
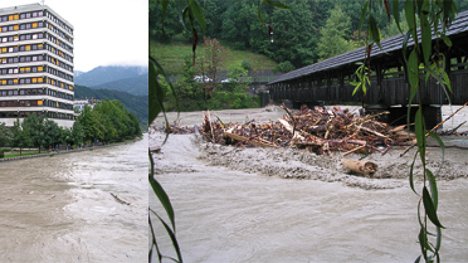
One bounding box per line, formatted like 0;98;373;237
200;107;415;155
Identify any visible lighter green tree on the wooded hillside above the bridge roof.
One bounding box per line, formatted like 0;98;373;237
317;6;353;60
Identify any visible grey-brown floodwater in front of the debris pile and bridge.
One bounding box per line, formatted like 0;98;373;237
150;135;468;262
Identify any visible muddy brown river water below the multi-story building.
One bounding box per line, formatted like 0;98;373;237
0;137;148;262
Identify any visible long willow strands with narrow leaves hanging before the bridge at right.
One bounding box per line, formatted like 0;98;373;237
352;0;456;262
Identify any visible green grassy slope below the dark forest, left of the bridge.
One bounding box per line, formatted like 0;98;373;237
150;41;277;75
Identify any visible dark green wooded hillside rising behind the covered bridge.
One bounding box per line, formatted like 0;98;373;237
149;0;468;71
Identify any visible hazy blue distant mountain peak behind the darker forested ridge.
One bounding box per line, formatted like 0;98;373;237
92;73;148;96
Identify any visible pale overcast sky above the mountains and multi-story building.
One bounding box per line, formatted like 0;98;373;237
0;0;148;71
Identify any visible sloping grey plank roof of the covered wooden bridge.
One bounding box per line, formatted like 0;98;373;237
268;11;468;85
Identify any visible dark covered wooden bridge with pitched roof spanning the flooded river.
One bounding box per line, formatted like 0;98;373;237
268;11;468;126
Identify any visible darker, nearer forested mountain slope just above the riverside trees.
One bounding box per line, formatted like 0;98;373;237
75;85;148;124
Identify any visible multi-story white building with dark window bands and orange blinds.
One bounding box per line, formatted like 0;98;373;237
0;4;74;127
